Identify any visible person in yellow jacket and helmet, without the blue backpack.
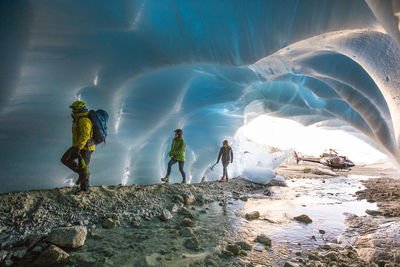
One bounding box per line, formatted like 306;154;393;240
61;101;95;195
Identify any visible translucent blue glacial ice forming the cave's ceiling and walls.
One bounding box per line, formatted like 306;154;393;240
0;0;400;192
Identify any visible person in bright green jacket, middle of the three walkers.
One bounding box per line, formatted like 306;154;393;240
161;129;186;184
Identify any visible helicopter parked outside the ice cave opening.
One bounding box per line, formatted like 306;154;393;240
294;148;355;171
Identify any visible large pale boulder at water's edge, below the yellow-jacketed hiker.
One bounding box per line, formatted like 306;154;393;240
47;226;87;248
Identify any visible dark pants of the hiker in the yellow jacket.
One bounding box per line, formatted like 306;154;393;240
61;147;93;191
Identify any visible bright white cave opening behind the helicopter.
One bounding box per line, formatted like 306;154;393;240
236;115;388;164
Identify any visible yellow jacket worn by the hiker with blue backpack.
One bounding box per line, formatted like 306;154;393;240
72;111;95;150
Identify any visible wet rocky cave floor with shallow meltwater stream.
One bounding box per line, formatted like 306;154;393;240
0;171;400;266
